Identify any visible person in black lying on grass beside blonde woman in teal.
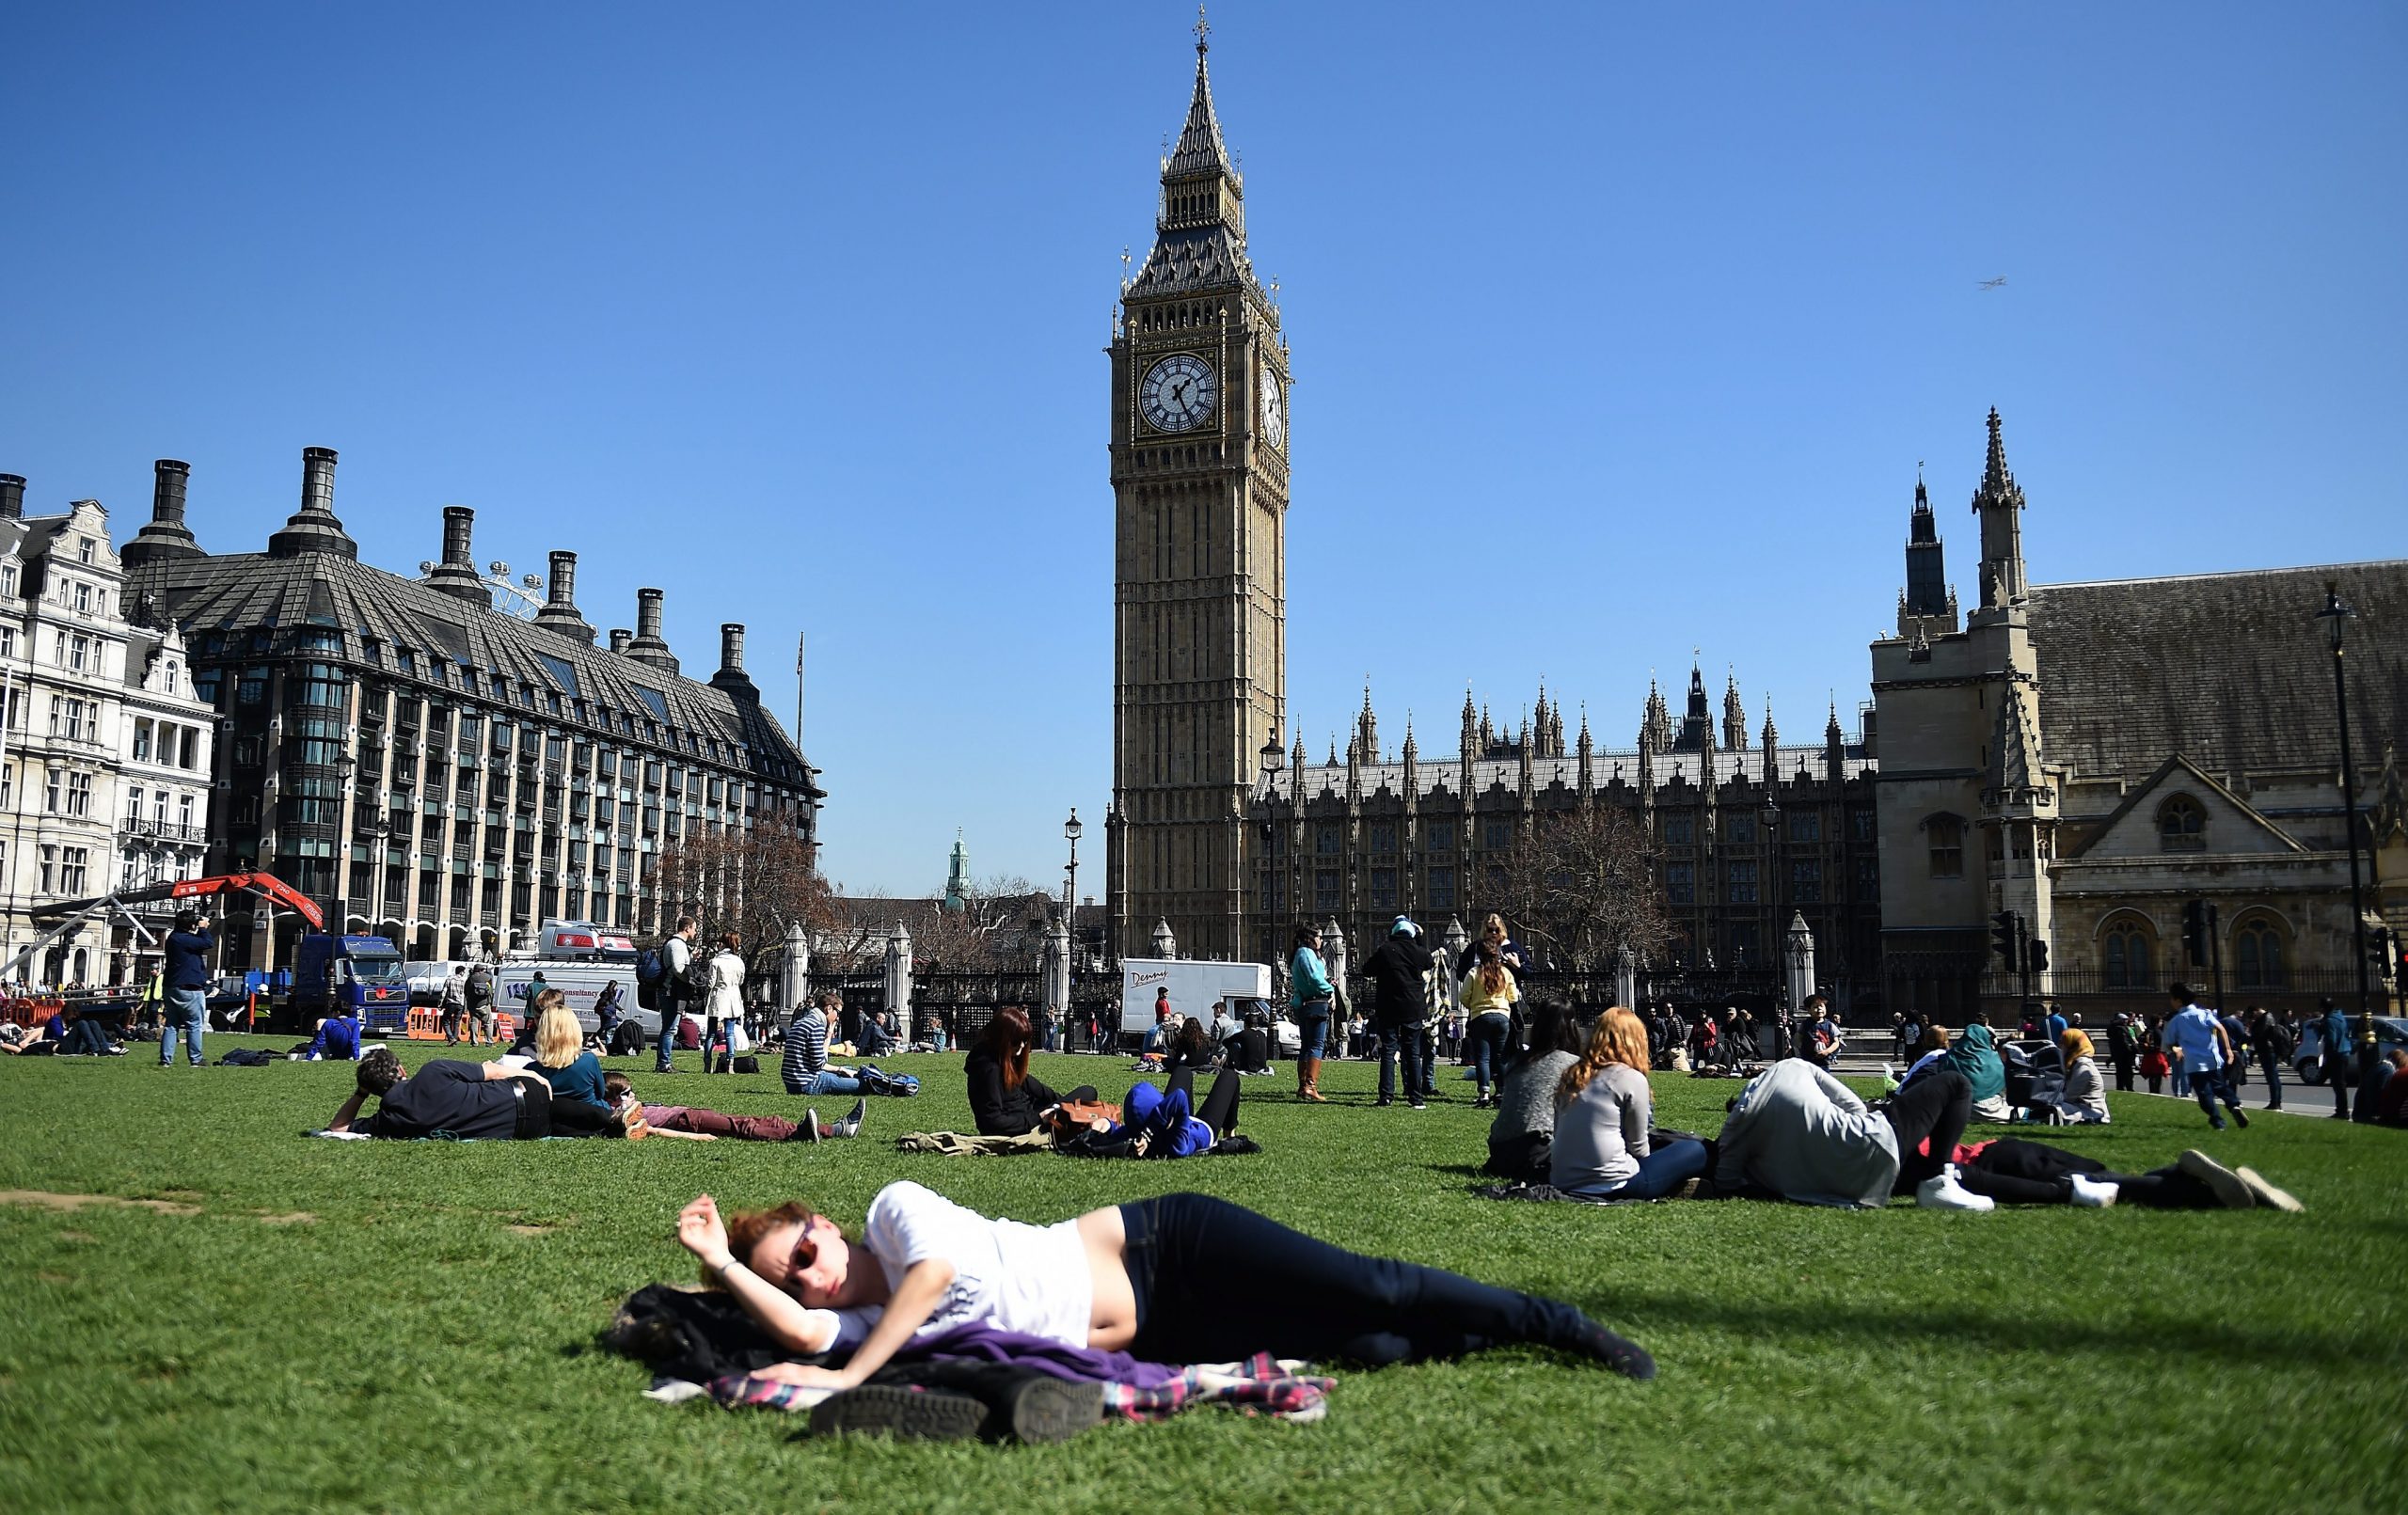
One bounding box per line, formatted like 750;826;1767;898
325;1048;648;1142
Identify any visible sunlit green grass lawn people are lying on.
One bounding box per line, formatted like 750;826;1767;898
0;1038;2408;1515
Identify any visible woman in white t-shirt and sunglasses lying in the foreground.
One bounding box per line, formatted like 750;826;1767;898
676;1183;1655;1390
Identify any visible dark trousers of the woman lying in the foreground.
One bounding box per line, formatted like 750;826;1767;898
1119;1194;1601;1365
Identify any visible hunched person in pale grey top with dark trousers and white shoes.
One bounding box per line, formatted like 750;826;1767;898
1714;1049;1991;1209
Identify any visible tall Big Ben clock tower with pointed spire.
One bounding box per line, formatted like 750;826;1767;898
1108;24;1289;963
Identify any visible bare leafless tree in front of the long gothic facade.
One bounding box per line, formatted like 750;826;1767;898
1493;802;1673;969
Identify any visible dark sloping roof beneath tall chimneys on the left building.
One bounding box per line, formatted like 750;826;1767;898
135;552;807;788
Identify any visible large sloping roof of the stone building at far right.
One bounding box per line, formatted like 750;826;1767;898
2030;559;2408;781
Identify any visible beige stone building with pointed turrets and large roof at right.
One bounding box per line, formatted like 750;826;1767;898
1871;412;2408;1021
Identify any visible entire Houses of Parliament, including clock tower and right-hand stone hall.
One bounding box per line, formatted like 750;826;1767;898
1105;20;2408;1017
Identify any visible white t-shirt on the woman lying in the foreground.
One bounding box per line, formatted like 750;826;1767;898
835;1183;1096;1347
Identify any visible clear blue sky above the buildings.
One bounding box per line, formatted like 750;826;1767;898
0;0;2408;893
